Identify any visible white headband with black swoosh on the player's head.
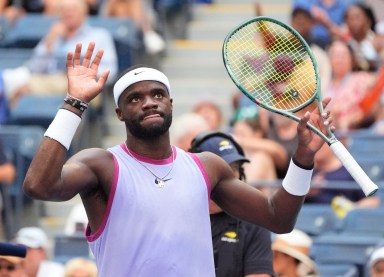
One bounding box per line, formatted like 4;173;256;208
113;67;171;105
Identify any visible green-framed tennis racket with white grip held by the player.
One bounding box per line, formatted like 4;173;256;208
223;16;378;196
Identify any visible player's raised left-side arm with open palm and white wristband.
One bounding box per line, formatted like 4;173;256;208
23;43;112;201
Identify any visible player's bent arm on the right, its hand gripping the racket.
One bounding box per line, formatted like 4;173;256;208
207;98;333;233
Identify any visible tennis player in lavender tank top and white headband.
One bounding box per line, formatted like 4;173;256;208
23;42;332;277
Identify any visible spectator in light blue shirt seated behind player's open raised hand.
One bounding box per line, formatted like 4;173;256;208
12;0;118;106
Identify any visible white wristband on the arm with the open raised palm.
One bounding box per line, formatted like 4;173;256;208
44;109;81;150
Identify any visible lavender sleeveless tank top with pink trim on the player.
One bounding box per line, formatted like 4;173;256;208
86;144;215;277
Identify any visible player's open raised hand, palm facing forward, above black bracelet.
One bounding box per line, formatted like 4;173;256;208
67;42;109;103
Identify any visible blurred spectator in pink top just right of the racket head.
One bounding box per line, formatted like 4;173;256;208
325;40;376;132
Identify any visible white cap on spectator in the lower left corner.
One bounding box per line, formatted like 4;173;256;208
14;227;48;249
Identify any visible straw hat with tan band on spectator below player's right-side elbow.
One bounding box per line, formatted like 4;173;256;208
272;229;316;272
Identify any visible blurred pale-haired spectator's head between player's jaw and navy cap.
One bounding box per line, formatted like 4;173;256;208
170;112;211;151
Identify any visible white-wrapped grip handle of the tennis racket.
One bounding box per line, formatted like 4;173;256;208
330;141;378;196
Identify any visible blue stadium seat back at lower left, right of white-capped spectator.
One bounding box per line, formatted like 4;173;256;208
53;234;92;263
